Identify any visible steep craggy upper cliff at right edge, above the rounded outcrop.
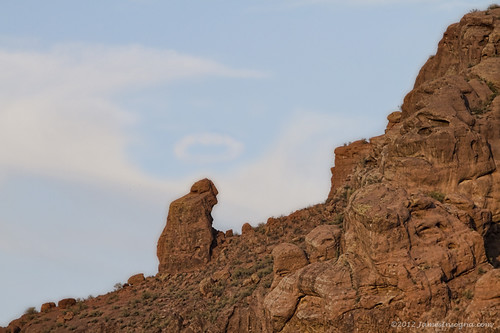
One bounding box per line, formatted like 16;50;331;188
390;9;500;228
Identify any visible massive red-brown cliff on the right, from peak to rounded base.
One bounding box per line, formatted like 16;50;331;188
264;9;500;332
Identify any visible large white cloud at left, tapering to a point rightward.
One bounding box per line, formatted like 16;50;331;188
0;44;265;192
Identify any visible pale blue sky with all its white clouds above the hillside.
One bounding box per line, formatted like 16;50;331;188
0;0;492;325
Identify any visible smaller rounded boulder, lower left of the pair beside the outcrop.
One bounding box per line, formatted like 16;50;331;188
272;243;308;286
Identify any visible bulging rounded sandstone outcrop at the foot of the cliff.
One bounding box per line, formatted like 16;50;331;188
264;183;492;332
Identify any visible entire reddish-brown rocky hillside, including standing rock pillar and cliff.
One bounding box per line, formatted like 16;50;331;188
4;8;500;332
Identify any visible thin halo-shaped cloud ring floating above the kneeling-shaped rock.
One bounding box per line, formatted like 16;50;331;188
174;133;243;163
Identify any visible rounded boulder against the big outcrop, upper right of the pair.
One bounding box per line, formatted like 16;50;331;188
305;225;342;262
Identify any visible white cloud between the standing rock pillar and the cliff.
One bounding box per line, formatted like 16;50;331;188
213;111;378;229
